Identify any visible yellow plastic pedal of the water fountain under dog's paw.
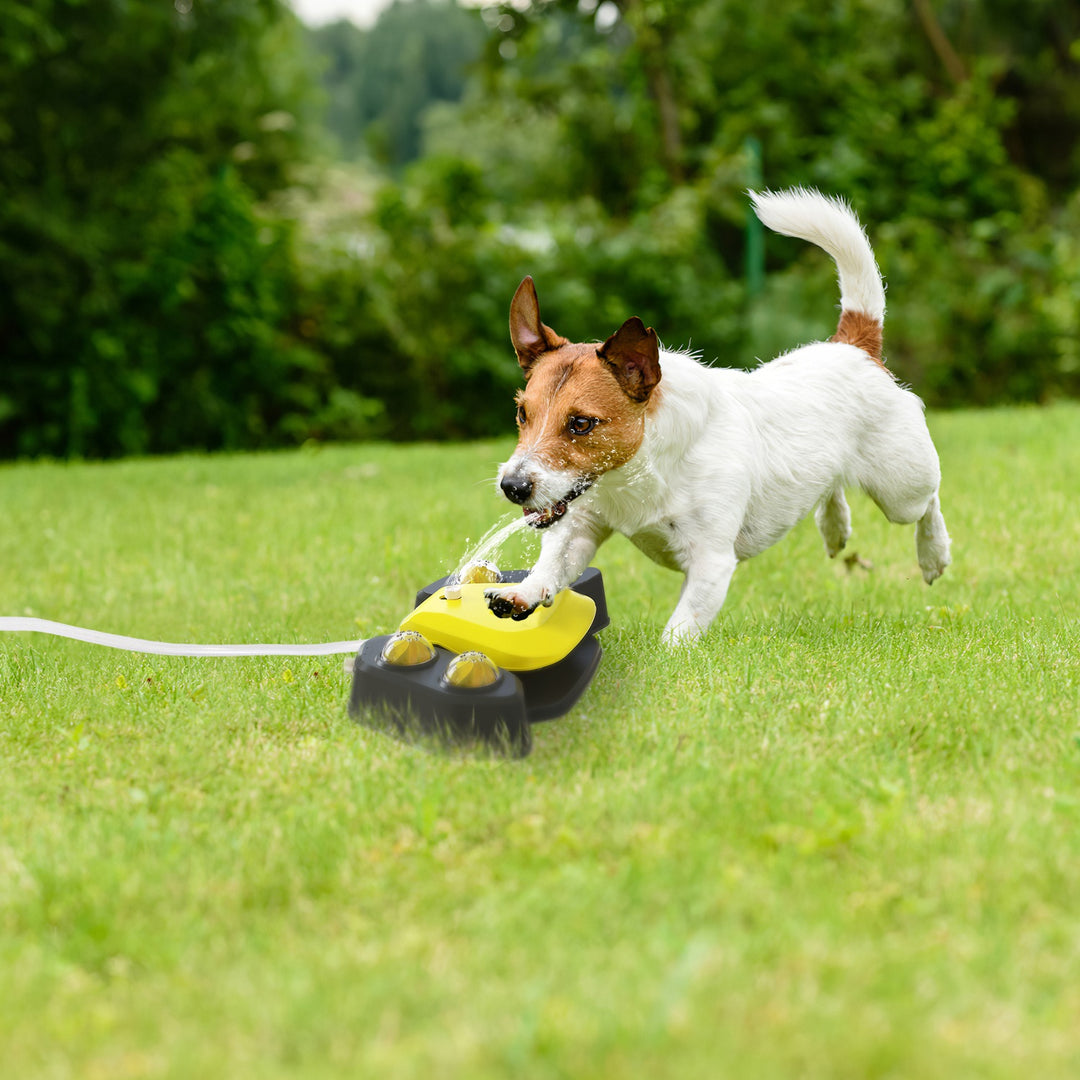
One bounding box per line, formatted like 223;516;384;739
399;582;596;672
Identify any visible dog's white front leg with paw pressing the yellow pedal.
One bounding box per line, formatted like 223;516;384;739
484;507;611;619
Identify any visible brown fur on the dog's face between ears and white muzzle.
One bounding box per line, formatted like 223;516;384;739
517;345;647;477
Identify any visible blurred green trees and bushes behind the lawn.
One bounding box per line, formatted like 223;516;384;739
0;0;1080;457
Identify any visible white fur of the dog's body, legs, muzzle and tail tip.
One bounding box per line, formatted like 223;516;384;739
491;189;949;644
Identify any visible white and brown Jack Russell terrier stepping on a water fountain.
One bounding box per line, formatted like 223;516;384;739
486;189;949;645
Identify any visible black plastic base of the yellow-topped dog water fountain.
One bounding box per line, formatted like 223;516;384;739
349;568;609;757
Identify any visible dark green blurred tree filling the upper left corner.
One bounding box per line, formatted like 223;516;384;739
0;0;371;456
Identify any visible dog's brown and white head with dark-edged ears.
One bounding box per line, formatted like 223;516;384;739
498;278;660;528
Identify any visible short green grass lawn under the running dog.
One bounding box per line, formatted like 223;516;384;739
0;405;1080;1080
